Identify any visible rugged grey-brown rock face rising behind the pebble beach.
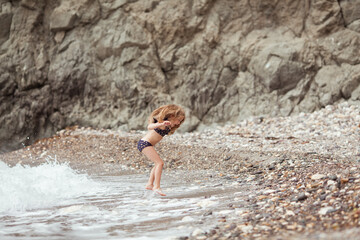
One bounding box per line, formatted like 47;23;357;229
0;0;360;151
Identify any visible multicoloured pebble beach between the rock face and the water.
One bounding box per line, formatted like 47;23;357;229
0;102;360;239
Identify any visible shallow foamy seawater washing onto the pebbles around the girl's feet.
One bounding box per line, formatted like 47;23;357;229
0;162;247;239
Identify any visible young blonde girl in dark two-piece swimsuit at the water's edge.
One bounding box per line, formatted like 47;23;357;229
137;104;185;196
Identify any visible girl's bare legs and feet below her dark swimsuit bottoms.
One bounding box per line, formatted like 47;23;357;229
142;146;165;196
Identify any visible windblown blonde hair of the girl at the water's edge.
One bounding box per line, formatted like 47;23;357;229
149;104;185;135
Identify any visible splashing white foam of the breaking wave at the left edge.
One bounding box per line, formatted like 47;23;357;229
0;162;98;214
